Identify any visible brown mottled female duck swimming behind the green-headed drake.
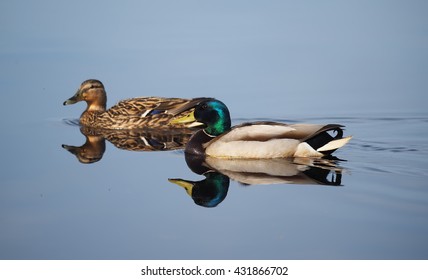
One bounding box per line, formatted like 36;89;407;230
64;79;214;129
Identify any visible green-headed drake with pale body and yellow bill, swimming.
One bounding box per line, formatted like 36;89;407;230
174;99;351;159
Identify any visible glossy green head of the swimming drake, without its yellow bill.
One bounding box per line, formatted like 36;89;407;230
194;99;231;136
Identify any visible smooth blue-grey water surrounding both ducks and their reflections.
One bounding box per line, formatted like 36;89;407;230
0;1;428;259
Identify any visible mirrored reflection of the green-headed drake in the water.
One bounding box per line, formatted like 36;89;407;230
168;153;343;207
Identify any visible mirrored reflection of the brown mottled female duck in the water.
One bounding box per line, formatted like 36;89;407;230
62;126;195;164
